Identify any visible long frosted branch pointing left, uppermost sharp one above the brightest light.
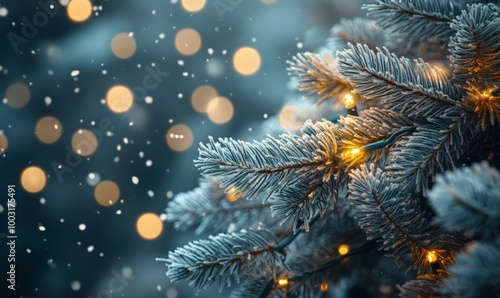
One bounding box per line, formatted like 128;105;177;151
337;44;461;118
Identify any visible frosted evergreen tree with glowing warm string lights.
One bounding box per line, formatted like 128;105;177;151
161;0;500;297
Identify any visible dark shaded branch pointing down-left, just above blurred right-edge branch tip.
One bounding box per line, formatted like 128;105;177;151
387;109;471;193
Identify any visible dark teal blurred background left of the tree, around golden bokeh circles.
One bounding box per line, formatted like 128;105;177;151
0;0;361;298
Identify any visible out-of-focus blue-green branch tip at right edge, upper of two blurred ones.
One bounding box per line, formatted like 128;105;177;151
429;162;500;239
